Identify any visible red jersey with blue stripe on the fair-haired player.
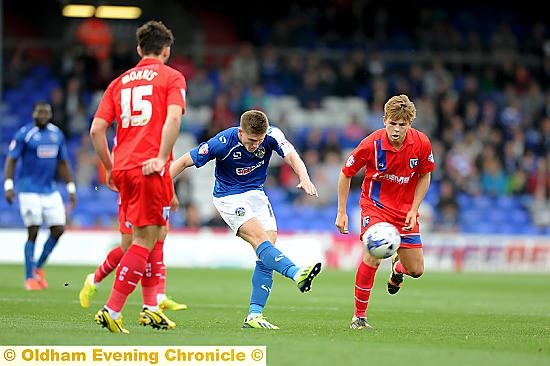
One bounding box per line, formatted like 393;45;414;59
342;128;435;217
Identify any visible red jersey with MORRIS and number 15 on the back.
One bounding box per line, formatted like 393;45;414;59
95;58;187;171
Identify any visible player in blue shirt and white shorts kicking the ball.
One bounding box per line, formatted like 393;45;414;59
170;110;321;329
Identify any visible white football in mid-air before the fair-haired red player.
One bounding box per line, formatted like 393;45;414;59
363;222;401;259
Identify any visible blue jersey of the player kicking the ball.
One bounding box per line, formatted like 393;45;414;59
190;126;295;197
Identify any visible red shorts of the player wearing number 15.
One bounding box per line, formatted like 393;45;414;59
112;166;174;232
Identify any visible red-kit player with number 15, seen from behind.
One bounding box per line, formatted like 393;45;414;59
90;21;186;333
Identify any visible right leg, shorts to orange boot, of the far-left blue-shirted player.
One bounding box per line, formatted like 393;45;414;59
35;192;66;288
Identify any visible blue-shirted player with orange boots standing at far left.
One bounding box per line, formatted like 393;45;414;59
4;102;76;291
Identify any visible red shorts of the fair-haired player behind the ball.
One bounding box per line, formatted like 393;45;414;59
359;207;422;248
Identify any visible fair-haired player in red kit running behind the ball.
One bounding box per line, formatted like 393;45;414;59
335;95;435;329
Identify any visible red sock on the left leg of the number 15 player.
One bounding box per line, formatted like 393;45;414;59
106;244;149;312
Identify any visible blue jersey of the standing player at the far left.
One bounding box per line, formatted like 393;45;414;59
8;123;68;193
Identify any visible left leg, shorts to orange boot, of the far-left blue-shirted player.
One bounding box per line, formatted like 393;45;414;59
18;193;42;291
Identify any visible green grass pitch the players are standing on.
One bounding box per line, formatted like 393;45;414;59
0;264;550;366
